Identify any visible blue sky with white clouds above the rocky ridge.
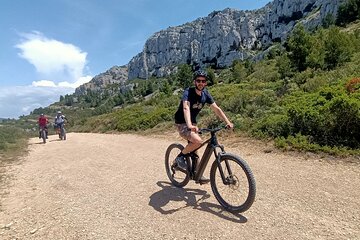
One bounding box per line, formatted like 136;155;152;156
0;0;270;118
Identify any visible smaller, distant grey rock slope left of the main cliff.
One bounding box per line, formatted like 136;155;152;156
75;66;128;95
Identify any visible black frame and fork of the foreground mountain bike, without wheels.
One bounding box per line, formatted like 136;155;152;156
189;128;232;185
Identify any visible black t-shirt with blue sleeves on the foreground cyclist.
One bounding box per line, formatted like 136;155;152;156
175;87;214;124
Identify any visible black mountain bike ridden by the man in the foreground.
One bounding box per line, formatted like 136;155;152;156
165;127;256;213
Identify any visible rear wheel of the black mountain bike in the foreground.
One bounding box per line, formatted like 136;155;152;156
165;143;190;188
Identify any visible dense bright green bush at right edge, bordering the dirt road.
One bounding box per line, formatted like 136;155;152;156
255;87;360;149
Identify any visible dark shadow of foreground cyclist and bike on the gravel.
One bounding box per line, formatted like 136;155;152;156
149;181;247;223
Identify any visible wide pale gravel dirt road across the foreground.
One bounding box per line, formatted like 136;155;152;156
0;133;360;240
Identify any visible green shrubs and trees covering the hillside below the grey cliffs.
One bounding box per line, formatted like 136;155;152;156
23;4;360;158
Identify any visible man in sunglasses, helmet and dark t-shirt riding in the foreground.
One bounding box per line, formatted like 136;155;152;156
175;70;234;182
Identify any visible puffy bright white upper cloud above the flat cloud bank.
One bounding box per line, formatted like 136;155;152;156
15;32;87;84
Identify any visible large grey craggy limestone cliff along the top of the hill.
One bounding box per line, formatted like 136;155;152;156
128;0;346;79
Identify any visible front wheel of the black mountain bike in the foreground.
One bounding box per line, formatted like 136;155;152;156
210;153;256;213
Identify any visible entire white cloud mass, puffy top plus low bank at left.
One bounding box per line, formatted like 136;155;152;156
0;32;92;118
